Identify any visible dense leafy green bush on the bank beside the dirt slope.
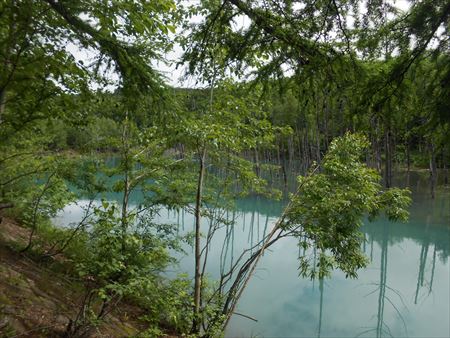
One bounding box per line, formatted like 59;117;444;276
68;201;189;334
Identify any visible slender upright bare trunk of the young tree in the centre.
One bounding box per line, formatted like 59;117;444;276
192;147;206;333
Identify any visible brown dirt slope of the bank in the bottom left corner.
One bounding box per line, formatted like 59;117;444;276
0;217;149;337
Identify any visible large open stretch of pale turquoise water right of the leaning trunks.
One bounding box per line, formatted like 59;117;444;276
227;184;450;337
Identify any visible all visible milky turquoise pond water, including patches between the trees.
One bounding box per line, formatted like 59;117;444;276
55;175;450;337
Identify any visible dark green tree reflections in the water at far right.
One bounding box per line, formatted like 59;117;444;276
359;199;450;337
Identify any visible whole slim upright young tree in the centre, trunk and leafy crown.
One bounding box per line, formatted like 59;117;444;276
174;82;282;334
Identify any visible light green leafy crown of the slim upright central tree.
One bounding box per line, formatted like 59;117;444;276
175;81;286;202
